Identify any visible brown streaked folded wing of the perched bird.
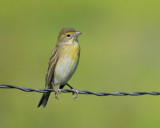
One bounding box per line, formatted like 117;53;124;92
45;47;58;88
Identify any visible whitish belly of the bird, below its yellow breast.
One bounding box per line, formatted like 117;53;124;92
54;55;79;85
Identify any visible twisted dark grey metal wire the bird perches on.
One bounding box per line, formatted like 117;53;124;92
0;84;160;96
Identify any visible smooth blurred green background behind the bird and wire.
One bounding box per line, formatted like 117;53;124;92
0;0;160;128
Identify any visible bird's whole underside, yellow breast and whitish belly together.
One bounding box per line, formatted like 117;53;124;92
54;43;80;85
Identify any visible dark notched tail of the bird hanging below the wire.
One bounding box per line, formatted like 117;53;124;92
38;92;51;108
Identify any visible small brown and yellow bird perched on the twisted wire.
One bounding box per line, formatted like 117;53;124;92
38;28;81;107
